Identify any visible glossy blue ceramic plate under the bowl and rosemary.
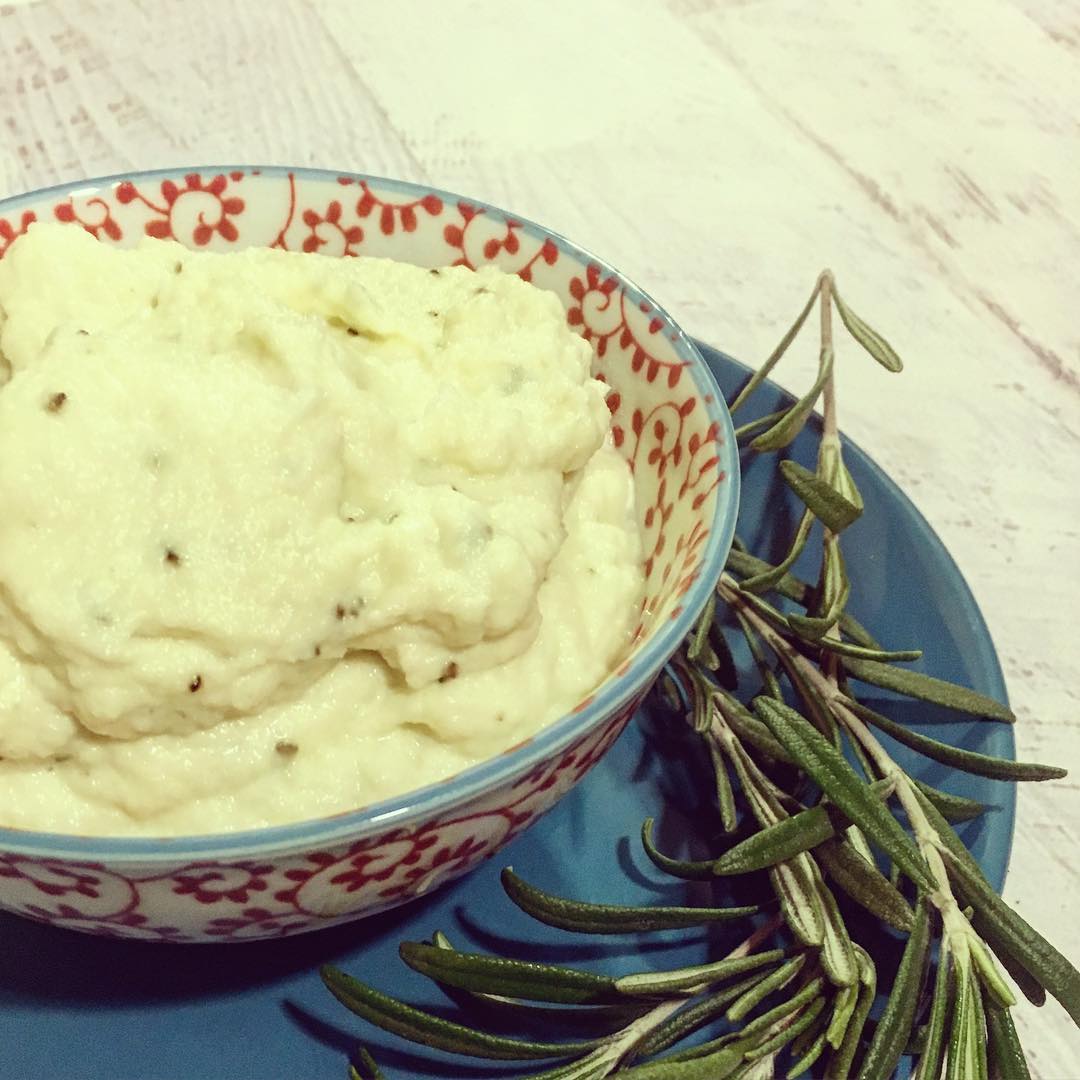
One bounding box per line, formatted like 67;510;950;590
0;347;1014;1080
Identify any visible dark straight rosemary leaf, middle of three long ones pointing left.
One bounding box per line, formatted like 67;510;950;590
399;942;618;1005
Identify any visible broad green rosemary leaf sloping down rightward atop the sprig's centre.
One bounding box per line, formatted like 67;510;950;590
755;698;934;889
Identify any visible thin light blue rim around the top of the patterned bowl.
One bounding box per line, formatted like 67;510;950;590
0;165;740;863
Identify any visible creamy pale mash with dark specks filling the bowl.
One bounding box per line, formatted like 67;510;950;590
0;225;643;835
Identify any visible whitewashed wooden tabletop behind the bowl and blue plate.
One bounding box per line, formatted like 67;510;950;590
0;0;1080;1078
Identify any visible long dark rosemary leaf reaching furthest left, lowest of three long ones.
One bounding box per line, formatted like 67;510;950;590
319;964;597;1062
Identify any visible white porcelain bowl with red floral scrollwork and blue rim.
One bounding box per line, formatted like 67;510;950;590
0;168;738;942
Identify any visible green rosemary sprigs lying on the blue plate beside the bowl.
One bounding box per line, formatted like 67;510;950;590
322;271;1080;1080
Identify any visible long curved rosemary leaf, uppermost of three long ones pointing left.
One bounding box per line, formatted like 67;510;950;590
502;866;759;934
